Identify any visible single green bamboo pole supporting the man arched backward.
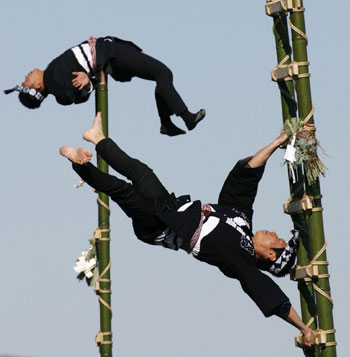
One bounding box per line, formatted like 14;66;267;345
96;71;112;357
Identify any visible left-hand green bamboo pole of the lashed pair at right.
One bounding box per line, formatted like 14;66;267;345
273;14;316;340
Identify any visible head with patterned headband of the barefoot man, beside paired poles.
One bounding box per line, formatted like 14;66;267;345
253;230;299;276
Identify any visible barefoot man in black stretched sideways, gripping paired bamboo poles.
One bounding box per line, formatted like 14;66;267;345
60;114;312;347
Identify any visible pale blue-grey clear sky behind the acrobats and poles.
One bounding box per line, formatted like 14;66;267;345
0;0;350;357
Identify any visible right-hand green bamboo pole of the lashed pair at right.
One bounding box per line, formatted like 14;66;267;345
290;0;336;357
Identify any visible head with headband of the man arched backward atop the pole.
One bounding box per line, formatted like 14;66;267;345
5;68;47;109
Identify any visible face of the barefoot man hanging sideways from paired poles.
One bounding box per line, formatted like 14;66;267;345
253;230;287;260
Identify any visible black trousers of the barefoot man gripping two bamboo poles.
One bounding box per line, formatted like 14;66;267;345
73;138;171;244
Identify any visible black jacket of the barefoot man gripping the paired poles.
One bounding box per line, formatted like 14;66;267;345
156;158;289;317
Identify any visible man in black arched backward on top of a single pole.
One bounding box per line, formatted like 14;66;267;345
5;36;205;136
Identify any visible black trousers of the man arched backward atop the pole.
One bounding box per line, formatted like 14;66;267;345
113;42;187;117
